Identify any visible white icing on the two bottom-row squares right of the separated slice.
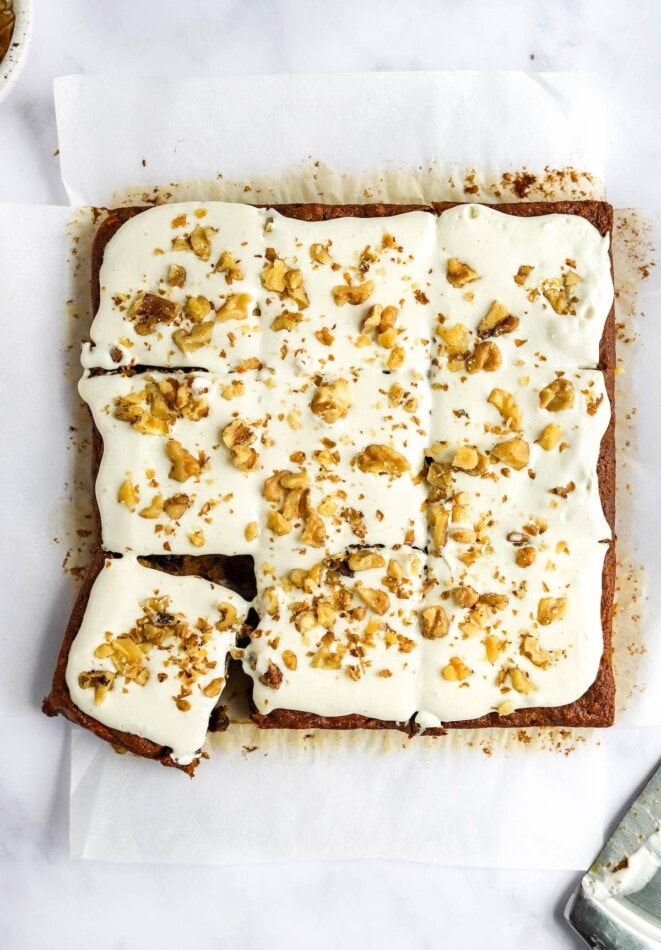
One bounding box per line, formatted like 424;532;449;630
244;542;606;729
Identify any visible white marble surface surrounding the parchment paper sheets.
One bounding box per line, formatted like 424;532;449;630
0;0;661;950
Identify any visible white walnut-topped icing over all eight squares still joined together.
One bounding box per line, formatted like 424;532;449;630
81;203;613;727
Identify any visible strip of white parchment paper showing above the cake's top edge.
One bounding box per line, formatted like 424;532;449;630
55;72;609;205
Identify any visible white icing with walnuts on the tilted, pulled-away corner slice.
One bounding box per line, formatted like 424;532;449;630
66;557;249;765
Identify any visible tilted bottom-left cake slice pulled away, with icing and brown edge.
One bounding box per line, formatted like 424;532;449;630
44;556;249;774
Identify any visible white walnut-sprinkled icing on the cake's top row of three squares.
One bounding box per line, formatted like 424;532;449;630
83;202;613;372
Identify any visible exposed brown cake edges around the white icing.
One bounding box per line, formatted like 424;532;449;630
44;201;615;760
